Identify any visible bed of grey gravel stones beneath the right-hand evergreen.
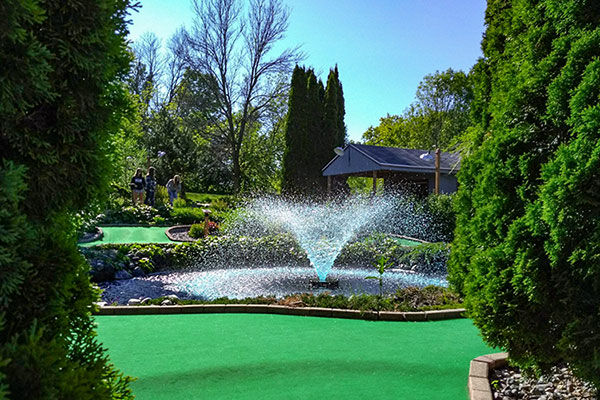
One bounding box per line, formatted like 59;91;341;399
490;365;598;400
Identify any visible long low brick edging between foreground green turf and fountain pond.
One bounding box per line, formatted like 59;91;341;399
93;304;465;321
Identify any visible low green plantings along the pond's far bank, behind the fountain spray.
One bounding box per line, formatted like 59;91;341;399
81;233;449;275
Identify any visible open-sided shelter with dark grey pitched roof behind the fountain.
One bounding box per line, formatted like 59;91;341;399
322;144;460;195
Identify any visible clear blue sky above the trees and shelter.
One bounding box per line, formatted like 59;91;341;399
130;0;486;140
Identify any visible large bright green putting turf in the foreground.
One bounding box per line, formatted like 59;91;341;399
95;314;494;400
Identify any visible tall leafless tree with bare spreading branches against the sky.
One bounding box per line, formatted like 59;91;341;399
186;0;303;191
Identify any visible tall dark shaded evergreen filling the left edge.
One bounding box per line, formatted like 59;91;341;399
0;0;132;399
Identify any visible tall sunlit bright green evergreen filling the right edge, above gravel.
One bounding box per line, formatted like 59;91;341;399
450;0;600;386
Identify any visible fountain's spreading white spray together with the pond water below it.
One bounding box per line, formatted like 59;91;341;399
96;196;447;303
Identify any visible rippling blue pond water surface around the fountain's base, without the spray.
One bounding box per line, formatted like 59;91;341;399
102;267;448;303
